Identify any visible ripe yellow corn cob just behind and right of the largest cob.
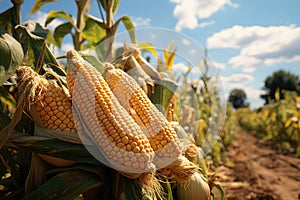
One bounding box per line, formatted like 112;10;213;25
104;64;180;168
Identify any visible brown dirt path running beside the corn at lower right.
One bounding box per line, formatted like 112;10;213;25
219;132;300;200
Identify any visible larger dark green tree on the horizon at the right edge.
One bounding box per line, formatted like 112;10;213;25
261;70;300;104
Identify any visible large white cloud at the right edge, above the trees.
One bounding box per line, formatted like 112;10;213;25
207;25;300;72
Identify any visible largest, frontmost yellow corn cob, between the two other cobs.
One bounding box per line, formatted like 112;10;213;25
67;50;154;172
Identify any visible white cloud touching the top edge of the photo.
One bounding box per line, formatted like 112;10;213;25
170;0;237;31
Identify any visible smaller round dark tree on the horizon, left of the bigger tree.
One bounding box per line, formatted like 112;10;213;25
228;89;249;109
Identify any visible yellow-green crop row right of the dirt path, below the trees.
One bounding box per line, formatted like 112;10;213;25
236;92;300;156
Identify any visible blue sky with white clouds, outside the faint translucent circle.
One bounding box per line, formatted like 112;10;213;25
0;0;300;108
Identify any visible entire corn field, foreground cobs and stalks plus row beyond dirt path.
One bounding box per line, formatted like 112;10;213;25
0;0;300;200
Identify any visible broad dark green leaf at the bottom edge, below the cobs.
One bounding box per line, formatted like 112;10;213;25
24;170;103;200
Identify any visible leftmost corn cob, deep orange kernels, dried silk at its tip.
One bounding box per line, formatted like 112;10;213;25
17;67;76;132
